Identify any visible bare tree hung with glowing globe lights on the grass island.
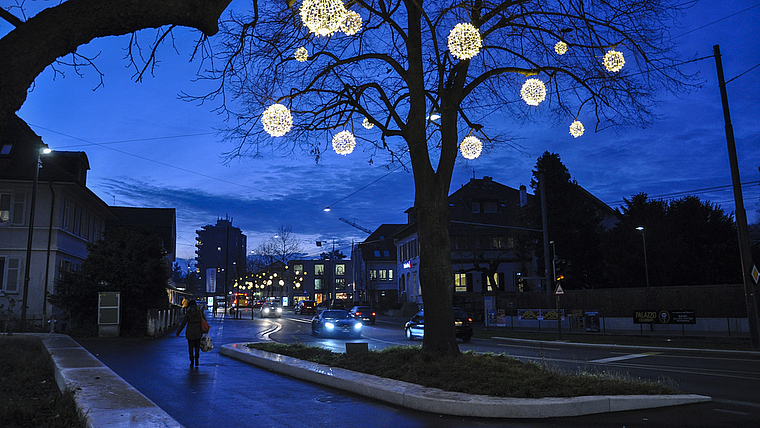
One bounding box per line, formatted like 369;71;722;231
190;0;689;355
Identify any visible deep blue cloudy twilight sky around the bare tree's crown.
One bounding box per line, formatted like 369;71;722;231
7;0;760;258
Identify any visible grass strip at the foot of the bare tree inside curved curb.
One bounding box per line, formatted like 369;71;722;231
248;342;677;398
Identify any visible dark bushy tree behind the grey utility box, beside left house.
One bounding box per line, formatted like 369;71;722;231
50;228;171;336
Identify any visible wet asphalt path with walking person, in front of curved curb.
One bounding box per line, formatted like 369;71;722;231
77;310;760;428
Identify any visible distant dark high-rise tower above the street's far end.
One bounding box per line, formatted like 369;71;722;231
194;217;247;298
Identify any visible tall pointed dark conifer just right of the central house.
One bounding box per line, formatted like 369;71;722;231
530;152;604;289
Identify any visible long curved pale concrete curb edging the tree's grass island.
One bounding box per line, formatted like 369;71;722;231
220;343;711;418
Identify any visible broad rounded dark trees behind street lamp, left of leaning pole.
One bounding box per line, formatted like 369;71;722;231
603;193;741;287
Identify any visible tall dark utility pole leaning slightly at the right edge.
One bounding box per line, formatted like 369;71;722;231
713;45;760;351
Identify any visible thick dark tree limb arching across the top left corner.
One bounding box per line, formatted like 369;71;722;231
0;0;231;135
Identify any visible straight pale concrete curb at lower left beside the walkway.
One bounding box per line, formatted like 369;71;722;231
33;333;183;428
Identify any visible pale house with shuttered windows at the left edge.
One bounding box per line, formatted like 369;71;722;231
0;119;117;329
